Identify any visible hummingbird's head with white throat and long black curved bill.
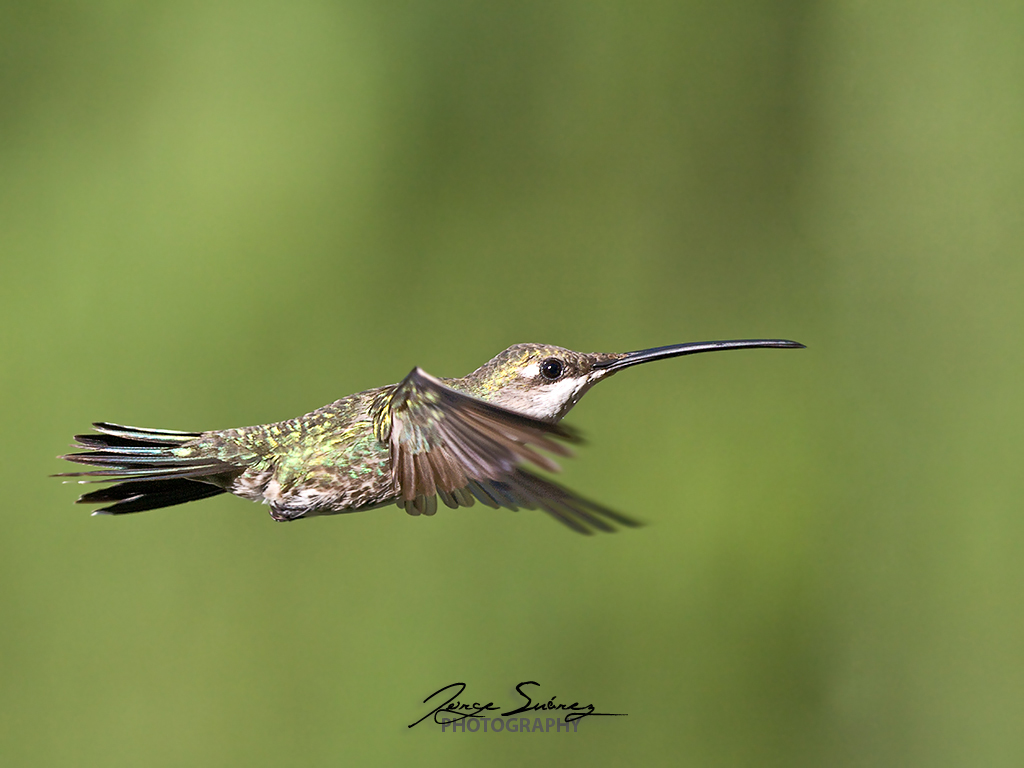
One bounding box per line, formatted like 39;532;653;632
460;339;804;422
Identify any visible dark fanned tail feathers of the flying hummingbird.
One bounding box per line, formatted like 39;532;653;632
55;422;241;515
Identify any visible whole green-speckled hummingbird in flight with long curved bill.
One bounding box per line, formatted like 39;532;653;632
56;339;804;534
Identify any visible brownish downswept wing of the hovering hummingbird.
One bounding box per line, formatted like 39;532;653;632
381;368;638;534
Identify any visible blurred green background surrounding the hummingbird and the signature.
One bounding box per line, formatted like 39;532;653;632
0;0;1024;767
